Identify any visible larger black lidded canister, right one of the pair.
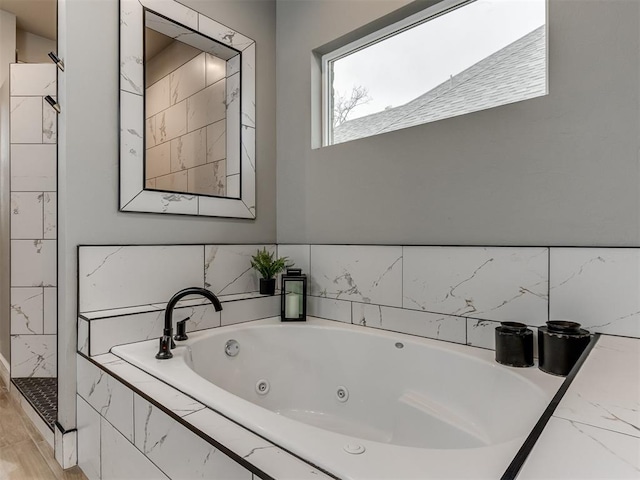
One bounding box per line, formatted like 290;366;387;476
538;320;591;377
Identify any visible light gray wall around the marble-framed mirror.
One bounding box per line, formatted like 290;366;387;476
58;0;276;428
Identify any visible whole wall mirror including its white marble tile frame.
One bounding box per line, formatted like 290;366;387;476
120;0;255;218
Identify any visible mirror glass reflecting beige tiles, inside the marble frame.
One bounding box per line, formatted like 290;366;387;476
144;10;241;198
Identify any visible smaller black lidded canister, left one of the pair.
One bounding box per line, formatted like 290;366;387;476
496;322;533;367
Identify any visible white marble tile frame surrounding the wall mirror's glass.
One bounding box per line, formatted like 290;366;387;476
118;0;256;219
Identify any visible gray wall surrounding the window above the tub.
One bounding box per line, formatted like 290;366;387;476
277;0;640;246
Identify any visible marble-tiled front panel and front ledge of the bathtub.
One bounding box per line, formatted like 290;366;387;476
77;354;329;480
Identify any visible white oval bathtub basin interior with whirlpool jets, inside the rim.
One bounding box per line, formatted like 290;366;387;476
184;321;550;449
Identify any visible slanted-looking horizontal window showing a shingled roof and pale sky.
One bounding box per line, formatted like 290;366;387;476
322;0;547;145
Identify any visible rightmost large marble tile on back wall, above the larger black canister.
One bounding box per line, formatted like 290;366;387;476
549;248;640;337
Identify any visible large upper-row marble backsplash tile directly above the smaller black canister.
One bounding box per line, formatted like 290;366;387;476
403;247;548;325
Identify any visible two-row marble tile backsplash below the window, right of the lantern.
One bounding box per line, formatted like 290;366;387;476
278;244;640;348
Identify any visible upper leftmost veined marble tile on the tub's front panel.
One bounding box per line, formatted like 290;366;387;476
76;354;133;441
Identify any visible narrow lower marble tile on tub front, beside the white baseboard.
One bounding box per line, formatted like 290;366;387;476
76;395;100;480
